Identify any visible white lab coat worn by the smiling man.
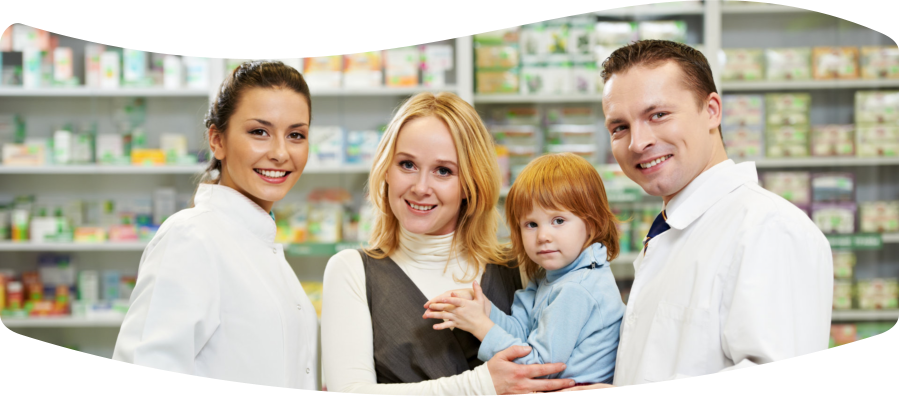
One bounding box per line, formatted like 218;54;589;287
614;160;833;386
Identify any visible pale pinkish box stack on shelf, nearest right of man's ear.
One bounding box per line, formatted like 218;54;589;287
721;95;765;158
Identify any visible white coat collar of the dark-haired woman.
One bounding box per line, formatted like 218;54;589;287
194;183;277;243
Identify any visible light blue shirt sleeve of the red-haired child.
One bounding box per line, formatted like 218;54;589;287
478;284;598;366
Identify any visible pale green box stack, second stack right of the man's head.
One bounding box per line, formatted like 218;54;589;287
765;93;812;158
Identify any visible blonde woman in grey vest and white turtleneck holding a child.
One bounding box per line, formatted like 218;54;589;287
322;93;574;395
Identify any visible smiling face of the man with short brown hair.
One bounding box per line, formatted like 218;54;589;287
602;61;726;203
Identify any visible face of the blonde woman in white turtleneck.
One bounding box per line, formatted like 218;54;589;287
387;116;462;235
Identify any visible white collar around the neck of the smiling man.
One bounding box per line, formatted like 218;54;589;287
665;159;759;230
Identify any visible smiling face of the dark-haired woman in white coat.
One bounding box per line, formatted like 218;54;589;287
209;88;310;211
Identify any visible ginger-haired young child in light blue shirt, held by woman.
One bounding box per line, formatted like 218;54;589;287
424;153;625;385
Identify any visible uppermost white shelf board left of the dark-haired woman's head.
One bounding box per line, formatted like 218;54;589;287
0;86;209;99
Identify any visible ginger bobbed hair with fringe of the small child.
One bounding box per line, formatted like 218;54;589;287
506;153;618;279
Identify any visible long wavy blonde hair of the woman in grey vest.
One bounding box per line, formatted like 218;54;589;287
365;92;508;282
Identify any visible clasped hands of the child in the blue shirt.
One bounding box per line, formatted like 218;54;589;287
424;282;493;341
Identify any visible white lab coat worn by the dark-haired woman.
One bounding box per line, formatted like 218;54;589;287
113;184;320;390
